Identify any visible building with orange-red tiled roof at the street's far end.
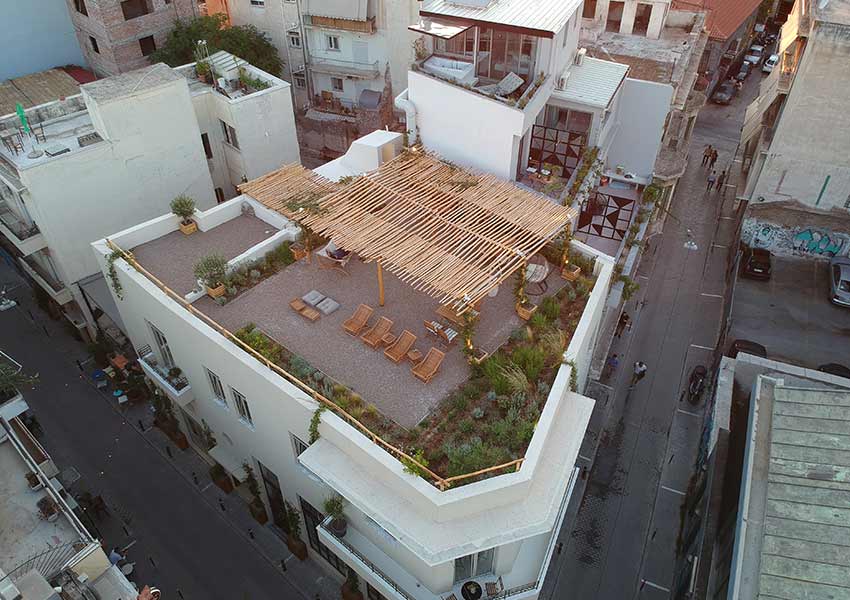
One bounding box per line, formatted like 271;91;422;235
672;0;762;95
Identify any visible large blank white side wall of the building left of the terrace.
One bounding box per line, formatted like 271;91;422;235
21;81;215;284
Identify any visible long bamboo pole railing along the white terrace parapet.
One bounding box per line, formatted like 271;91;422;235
106;239;525;491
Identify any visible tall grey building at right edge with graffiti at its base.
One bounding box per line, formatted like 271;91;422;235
741;0;850;257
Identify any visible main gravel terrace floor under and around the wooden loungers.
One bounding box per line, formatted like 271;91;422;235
194;253;566;427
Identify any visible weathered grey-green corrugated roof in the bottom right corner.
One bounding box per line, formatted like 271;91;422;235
739;380;850;598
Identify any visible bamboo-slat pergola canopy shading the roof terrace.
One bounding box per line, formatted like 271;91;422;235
241;150;576;312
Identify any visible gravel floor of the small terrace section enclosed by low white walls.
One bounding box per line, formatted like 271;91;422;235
132;215;278;294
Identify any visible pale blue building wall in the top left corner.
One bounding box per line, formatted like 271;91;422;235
0;0;85;81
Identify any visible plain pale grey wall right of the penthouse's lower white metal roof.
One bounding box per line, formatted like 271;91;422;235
607;78;673;178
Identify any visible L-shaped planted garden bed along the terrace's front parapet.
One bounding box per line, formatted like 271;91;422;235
229;245;594;485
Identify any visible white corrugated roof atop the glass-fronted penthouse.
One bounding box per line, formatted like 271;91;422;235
419;0;582;37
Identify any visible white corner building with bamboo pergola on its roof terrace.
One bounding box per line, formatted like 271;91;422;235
93;131;613;600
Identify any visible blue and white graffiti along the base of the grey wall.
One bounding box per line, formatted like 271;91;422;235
741;219;850;258
